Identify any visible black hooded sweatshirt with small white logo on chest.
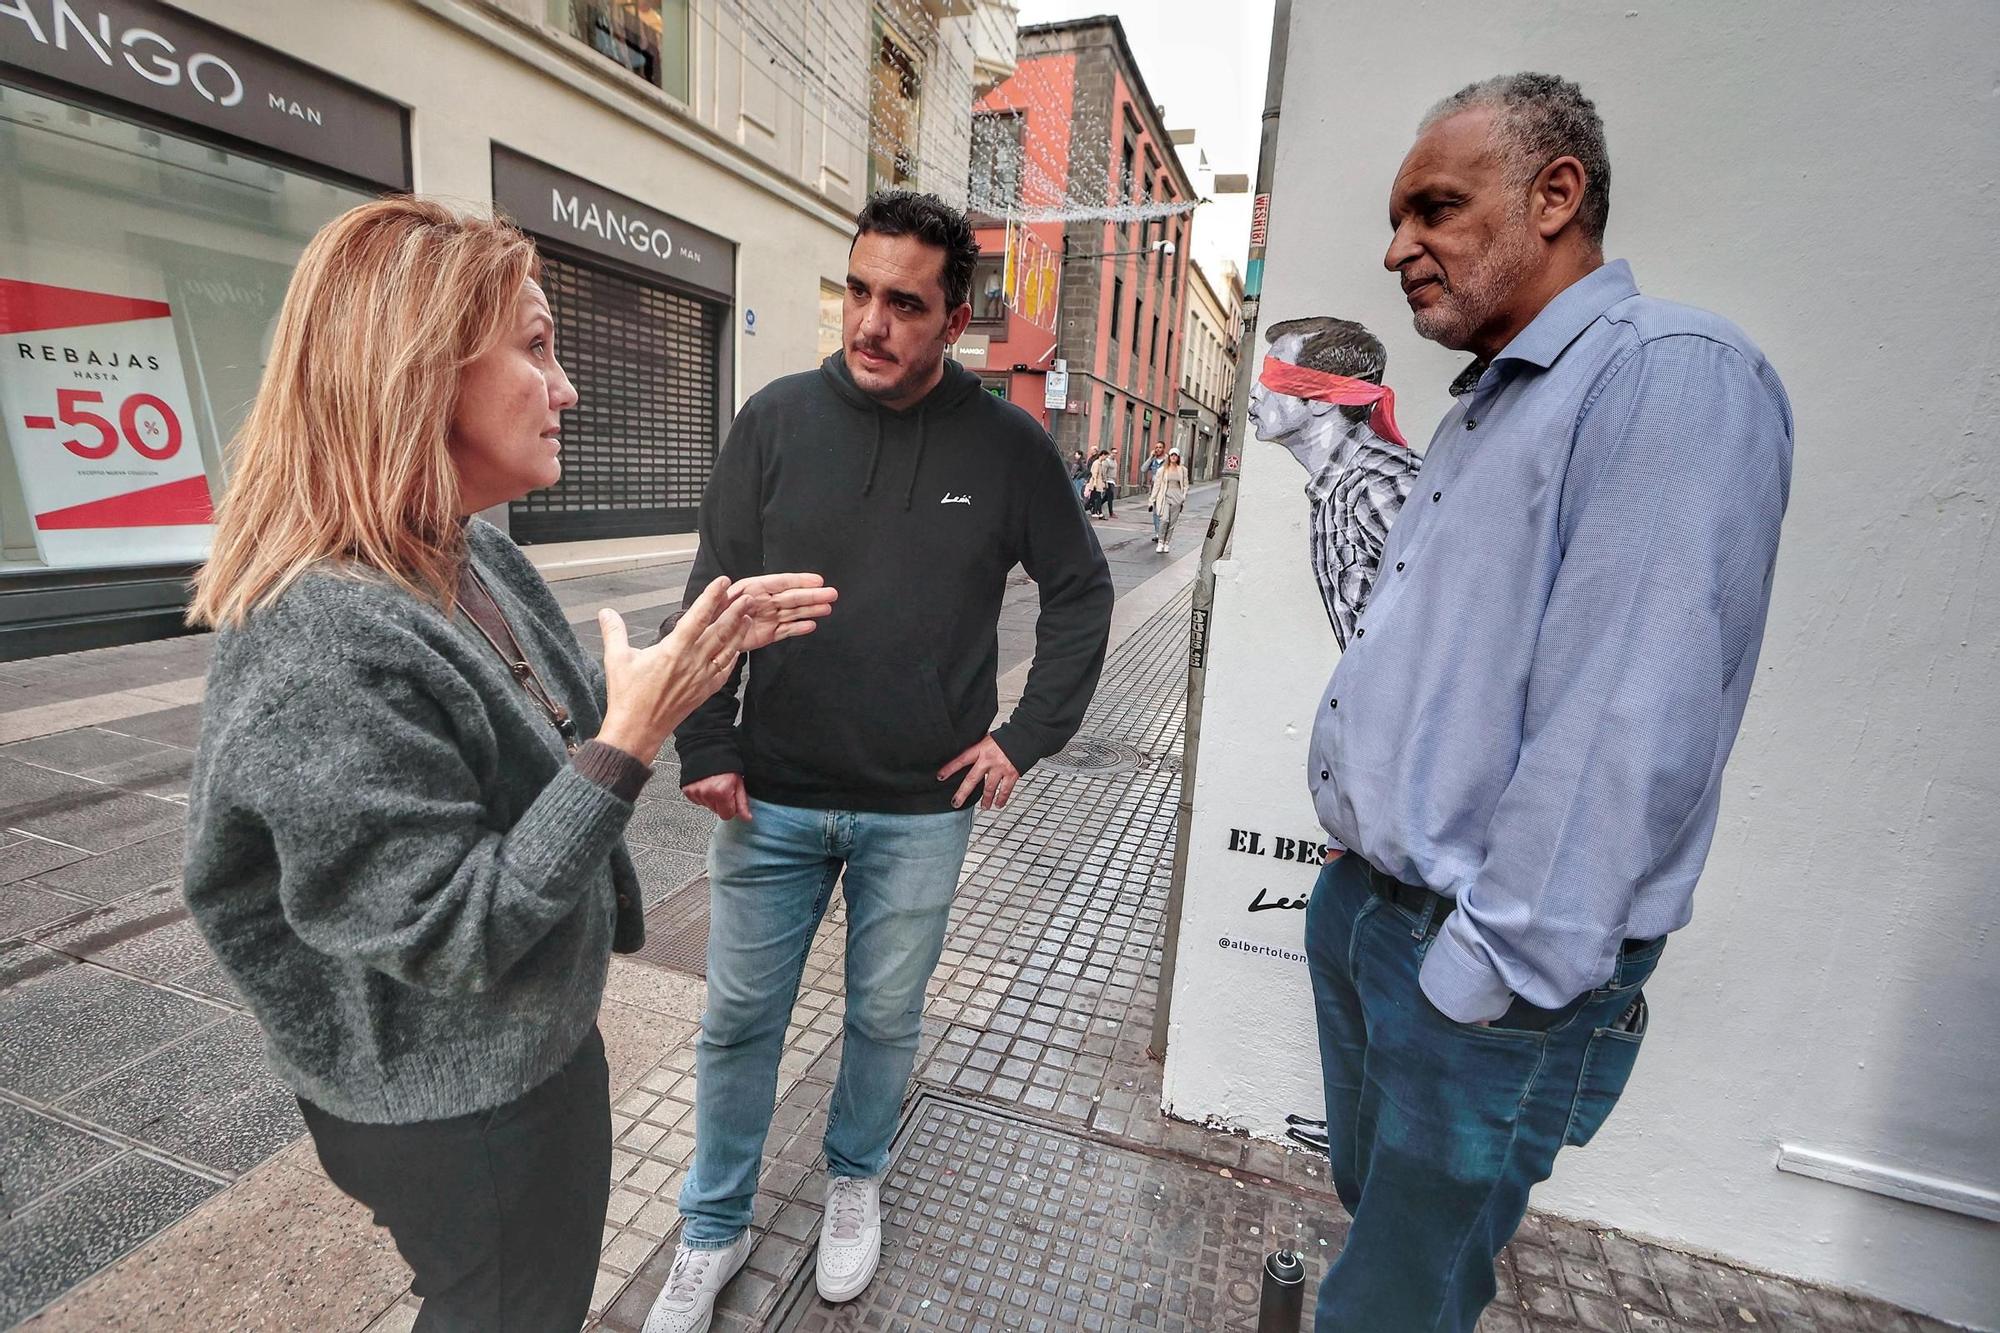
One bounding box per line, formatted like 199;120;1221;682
674;352;1112;815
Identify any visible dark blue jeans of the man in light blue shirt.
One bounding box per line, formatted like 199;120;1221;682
1306;853;1664;1333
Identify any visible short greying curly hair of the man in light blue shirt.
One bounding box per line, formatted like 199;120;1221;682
1418;72;1612;248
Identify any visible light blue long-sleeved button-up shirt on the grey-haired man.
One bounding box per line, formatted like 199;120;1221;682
1308;262;1792;1023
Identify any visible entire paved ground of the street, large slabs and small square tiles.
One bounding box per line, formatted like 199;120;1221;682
0;494;1946;1333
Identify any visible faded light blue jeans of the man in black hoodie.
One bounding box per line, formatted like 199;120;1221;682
680;801;976;1249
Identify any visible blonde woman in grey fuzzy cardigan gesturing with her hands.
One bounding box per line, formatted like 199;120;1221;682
186;198;834;1333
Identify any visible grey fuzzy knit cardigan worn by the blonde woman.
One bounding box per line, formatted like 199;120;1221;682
186;520;650;1123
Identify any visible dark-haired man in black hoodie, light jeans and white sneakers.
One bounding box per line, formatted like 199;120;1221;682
646;192;1112;1333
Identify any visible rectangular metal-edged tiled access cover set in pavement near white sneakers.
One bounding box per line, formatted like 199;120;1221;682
770;1093;1338;1333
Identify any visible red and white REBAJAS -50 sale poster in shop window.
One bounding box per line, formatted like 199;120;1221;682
0;278;214;566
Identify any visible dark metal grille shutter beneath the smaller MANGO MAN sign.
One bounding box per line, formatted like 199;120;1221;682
508;252;722;542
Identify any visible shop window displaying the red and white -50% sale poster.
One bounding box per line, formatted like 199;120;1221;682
0;86;370;572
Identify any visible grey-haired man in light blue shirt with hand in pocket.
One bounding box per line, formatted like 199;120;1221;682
1306;74;1792;1333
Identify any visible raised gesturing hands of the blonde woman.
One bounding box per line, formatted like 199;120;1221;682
598;574;836;763
